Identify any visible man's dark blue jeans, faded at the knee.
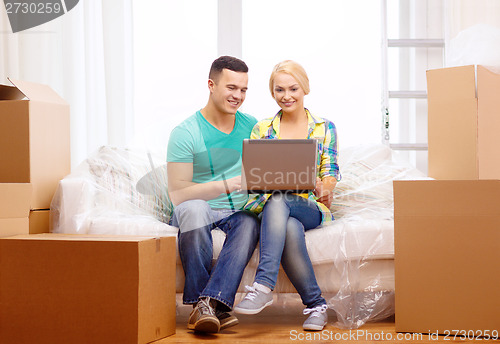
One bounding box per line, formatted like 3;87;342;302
172;200;259;311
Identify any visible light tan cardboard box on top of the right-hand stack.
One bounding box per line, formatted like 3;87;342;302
427;66;500;180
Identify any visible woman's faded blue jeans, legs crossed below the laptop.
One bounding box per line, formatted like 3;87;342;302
255;193;326;308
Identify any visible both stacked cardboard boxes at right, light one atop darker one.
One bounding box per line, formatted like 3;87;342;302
394;66;500;339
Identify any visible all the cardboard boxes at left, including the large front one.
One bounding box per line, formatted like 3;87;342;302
0;80;176;344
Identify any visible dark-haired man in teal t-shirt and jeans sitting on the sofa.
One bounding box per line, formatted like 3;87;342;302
167;56;259;333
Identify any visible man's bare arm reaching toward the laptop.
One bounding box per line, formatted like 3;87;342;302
167;162;241;205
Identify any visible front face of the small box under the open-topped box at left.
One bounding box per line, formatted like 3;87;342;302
0;183;32;238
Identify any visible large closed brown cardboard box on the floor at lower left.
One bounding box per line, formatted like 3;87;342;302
0;234;176;344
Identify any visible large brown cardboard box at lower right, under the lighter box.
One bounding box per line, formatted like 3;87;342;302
394;180;500;336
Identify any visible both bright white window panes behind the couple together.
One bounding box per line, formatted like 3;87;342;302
134;0;381;152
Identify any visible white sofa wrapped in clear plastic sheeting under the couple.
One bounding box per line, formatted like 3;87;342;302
51;144;426;329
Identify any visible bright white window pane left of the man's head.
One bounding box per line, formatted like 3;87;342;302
133;0;217;150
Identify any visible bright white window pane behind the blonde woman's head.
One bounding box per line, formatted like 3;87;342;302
243;0;381;147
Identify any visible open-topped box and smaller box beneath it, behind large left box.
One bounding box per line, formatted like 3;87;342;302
0;80;71;237
